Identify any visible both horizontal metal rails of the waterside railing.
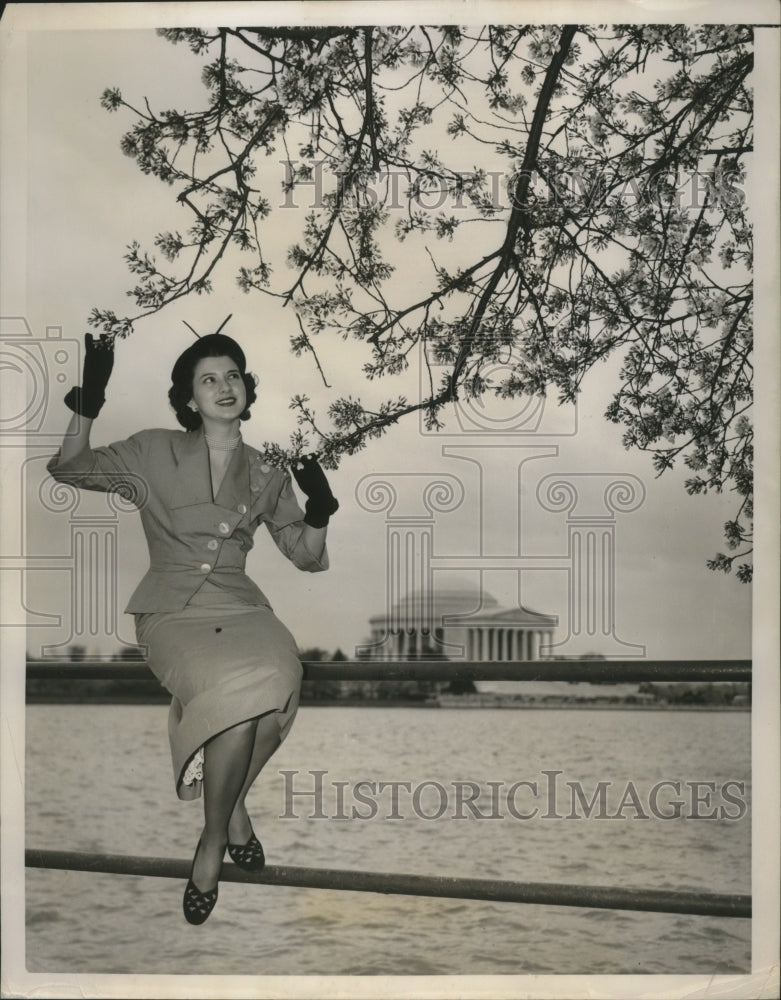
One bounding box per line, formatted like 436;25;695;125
25;660;751;918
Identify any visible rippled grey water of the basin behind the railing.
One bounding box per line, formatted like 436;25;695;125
26;705;751;975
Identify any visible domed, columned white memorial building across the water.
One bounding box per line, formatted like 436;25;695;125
361;580;558;660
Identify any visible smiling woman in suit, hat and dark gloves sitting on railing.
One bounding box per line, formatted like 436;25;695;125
48;333;339;924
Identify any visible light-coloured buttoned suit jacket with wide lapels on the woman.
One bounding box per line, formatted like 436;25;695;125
47;429;328;614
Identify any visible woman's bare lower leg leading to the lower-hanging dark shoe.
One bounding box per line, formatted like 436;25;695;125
192;719;258;892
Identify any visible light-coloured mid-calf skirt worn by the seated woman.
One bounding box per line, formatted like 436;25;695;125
135;583;303;799
